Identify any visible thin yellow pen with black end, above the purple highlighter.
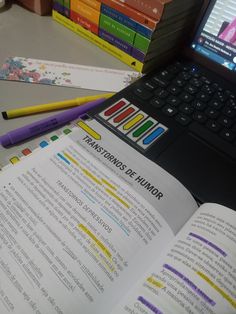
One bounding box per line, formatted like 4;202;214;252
2;93;114;120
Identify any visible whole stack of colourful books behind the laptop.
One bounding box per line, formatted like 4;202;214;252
53;0;203;73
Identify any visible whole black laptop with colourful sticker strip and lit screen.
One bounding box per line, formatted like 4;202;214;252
91;0;236;210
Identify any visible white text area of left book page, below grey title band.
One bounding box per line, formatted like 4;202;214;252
0;132;184;314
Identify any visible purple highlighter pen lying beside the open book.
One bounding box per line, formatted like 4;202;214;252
0;98;105;147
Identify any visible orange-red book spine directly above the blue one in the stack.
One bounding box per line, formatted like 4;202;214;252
99;0;158;30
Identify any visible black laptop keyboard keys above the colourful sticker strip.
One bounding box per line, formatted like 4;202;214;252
132;62;236;159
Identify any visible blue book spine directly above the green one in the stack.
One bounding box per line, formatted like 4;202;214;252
101;3;153;38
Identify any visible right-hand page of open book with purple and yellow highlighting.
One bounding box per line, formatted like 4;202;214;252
112;204;236;314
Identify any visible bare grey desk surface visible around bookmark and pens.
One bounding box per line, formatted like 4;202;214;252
0;4;132;165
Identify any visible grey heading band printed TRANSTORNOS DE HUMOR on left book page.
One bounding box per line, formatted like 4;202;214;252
70;119;198;233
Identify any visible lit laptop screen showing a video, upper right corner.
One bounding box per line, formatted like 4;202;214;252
192;0;236;71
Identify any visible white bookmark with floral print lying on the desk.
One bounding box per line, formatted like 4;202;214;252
0;57;141;92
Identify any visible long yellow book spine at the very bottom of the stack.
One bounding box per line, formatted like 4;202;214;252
52;10;144;72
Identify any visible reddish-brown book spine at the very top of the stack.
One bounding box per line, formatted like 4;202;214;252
122;0;172;20
